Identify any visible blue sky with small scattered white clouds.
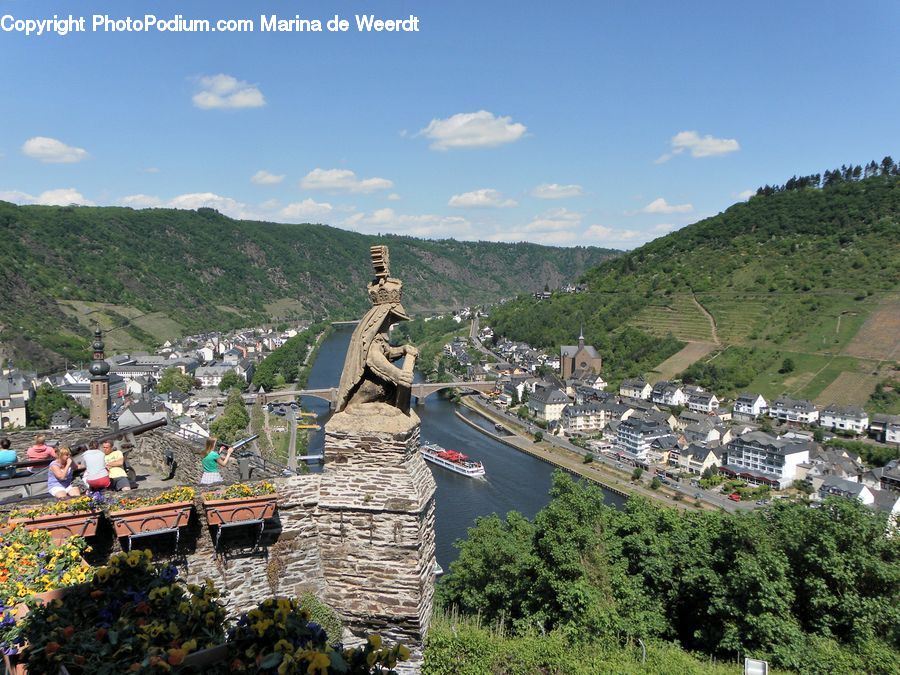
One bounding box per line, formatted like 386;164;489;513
0;0;900;248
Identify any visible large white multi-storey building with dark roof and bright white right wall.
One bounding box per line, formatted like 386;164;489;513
720;431;817;490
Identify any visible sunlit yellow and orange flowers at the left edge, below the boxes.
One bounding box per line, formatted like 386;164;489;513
0;527;92;672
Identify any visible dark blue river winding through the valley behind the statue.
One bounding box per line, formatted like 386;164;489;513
302;326;622;570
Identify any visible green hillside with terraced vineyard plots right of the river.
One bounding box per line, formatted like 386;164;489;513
492;176;900;403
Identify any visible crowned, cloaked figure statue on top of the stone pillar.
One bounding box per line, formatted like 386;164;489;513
336;246;419;413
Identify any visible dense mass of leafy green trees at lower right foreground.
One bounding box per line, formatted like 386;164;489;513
437;472;900;673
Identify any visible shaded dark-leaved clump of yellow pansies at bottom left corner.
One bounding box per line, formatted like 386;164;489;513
22;551;226;675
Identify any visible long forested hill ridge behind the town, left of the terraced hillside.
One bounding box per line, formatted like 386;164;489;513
0;202;616;366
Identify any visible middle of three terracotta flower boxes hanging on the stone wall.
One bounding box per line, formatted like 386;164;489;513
107;486;194;537
